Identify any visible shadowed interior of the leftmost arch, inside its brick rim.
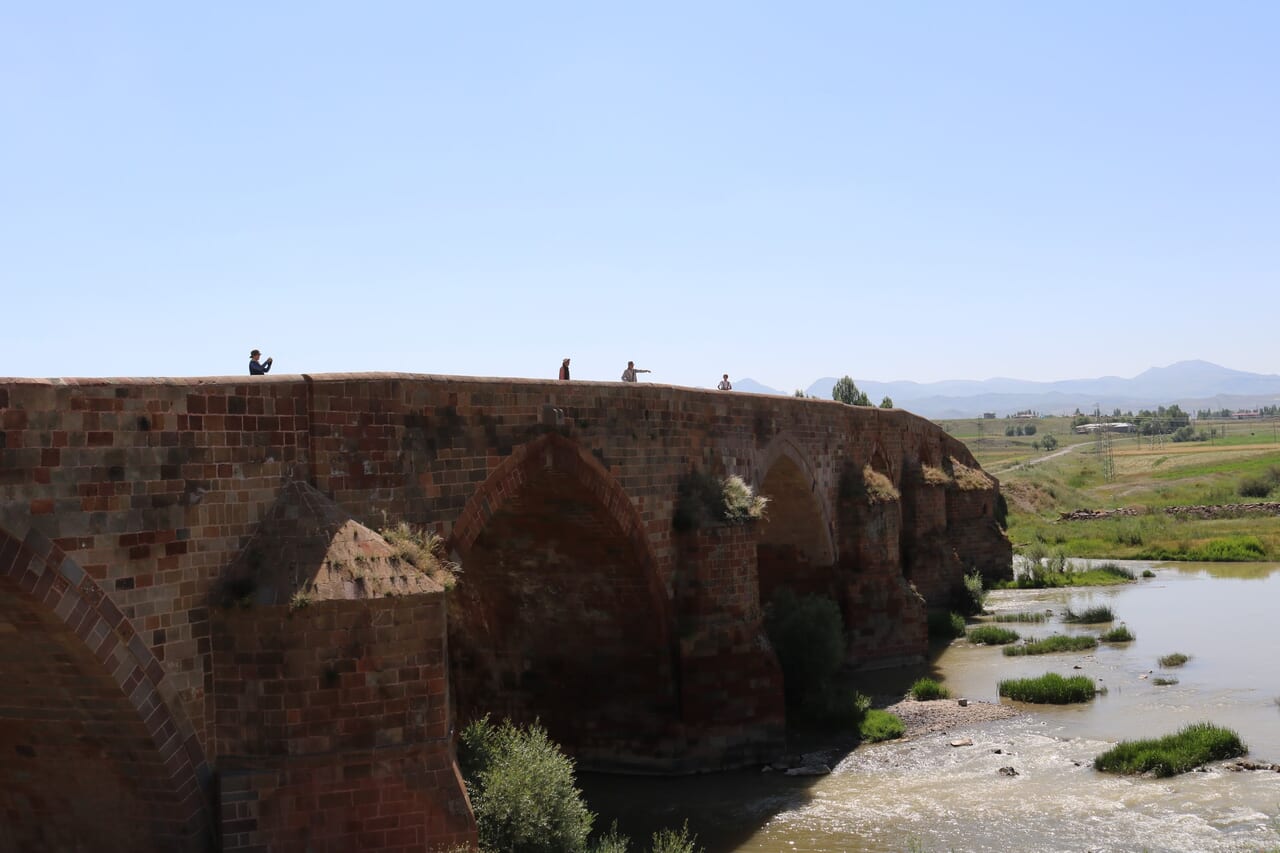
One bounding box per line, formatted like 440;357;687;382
0;578;183;853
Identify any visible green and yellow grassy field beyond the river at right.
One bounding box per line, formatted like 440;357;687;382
940;418;1280;561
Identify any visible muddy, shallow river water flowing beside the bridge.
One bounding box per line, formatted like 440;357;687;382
582;562;1280;853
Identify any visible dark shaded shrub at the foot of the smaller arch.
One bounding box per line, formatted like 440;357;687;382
764;587;845;710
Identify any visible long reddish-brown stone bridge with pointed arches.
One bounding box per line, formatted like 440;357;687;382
0;374;1010;850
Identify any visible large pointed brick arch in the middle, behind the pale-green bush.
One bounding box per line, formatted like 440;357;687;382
449;433;678;767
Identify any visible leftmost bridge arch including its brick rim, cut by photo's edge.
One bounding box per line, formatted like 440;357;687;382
0;529;212;852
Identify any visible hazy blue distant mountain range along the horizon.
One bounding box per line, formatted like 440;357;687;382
733;361;1280;419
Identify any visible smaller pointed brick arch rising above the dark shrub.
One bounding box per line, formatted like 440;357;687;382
756;435;836;603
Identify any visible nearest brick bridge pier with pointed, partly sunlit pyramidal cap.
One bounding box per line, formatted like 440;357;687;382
210;483;475;853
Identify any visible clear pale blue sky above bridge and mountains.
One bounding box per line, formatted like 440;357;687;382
0;1;1280;391
